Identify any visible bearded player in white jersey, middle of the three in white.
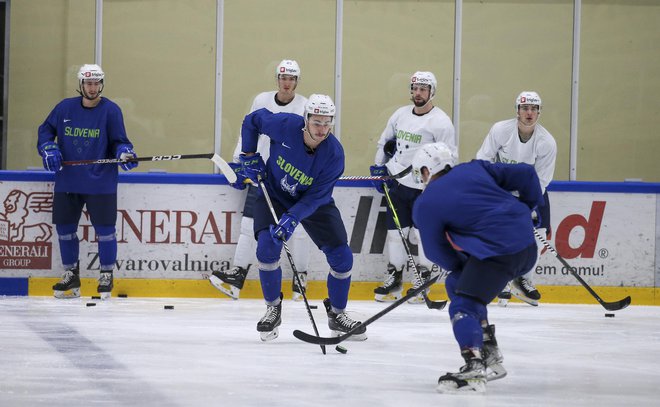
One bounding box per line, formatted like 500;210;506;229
370;72;456;303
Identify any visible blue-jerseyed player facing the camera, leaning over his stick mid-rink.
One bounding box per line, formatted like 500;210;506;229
239;95;367;341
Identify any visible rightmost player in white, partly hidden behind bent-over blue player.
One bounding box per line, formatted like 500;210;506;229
477;91;557;306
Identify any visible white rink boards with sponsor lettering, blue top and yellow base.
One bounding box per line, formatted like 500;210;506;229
0;171;660;305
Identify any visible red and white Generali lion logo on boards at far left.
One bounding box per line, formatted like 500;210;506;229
0;189;53;269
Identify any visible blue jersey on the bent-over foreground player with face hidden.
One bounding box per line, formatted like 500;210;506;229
413;160;543;270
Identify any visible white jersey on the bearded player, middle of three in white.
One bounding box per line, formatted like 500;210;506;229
374;105;456;189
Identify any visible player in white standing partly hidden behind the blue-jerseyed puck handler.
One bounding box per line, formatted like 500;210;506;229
209;59;310;301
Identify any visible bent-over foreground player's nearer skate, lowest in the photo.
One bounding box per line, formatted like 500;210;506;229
436;350;487;394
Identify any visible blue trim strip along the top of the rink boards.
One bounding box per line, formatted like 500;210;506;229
0;171;660;194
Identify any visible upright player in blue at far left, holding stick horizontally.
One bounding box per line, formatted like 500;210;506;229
37;65;138;299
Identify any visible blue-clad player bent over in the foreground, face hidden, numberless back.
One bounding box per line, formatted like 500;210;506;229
413;143;544;393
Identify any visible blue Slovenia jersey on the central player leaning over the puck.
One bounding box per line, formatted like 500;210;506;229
241;109;344;220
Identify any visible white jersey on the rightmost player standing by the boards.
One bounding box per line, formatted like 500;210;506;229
477;119;557;193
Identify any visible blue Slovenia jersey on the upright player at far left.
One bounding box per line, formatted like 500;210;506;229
37;96;133;194
